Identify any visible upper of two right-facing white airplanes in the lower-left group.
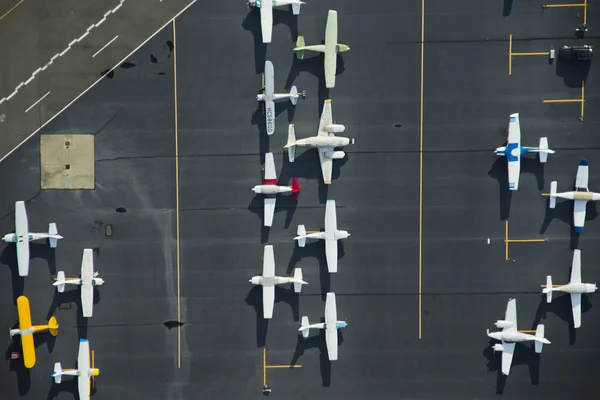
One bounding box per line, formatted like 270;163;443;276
53;249;104;318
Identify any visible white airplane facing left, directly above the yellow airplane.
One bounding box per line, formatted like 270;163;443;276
2;201;63;276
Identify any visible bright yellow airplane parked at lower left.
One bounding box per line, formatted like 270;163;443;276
10;296;58;368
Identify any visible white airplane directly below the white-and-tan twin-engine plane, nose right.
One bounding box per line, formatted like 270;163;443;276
294;200;350;273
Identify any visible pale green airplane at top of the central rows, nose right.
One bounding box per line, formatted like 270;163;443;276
294;10;350;88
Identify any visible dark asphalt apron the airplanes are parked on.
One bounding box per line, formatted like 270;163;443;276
0;0;600;400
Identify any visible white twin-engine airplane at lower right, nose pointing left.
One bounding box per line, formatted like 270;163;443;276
487;299;550;375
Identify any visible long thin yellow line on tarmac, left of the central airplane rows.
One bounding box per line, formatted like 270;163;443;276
173;20;181;368
